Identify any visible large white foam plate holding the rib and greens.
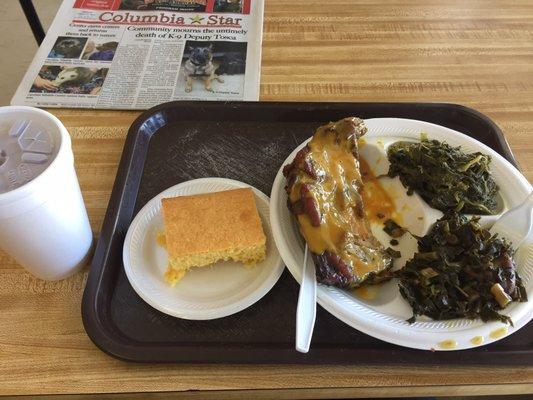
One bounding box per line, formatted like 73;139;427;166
270;118;533;350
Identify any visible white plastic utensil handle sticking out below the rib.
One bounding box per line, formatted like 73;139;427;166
296;245;316;353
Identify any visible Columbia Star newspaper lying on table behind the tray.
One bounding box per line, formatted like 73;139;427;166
11;0;264;109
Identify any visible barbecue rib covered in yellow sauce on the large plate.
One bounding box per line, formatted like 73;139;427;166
283;117;392;288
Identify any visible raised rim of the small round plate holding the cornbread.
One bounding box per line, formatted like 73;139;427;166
122;177;285;321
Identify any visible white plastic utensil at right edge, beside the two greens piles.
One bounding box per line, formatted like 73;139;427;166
490;192;533;249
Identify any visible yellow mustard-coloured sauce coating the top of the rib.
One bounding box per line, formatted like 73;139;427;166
290;120;384;278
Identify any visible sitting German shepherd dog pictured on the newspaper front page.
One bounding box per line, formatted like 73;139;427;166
183;43;224;93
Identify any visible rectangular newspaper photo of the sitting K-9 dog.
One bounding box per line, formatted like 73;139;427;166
176;40;247;99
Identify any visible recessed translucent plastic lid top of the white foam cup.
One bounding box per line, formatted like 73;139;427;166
0;119;57;194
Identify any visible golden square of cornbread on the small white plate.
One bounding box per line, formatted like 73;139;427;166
161;188;266;286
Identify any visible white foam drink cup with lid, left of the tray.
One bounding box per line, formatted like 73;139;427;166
0;106;93;280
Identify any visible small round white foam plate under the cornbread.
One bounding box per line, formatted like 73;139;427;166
123;178;285;320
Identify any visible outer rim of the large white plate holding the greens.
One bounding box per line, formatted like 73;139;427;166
270;117;533;351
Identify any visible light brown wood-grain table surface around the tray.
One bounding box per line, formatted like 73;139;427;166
0;0;533;399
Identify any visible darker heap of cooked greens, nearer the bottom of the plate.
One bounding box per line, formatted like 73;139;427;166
397;214;527;323
